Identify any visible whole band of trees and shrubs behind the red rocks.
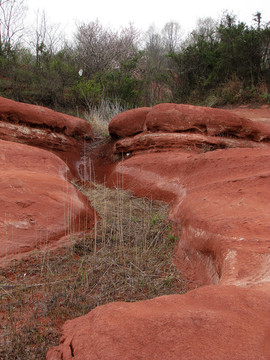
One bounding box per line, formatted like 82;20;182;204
0;13;270;110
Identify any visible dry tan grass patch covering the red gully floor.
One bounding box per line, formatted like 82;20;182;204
0;185;186;360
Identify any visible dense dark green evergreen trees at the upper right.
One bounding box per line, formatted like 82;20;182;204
170;14;270;103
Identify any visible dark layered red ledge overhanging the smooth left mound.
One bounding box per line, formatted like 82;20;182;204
0;97;93;176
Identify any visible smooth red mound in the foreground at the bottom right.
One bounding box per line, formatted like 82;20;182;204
47;285;270;360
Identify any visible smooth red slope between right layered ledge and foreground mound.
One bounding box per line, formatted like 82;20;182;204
111;148;270;285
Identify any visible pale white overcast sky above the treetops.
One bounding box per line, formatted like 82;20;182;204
25;0;270;38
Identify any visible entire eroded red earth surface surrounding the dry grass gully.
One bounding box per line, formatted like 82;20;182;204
0;98;270;360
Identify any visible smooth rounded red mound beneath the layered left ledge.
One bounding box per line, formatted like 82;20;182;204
0;140;93;266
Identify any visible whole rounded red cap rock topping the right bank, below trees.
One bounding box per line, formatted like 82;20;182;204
109;103;270;141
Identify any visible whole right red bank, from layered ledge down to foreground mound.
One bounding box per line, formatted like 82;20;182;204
47;104;270;360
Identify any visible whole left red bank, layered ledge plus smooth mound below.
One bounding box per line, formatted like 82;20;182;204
0;98;94;266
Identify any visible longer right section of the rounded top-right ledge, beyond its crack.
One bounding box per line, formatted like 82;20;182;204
145;104;270;141
